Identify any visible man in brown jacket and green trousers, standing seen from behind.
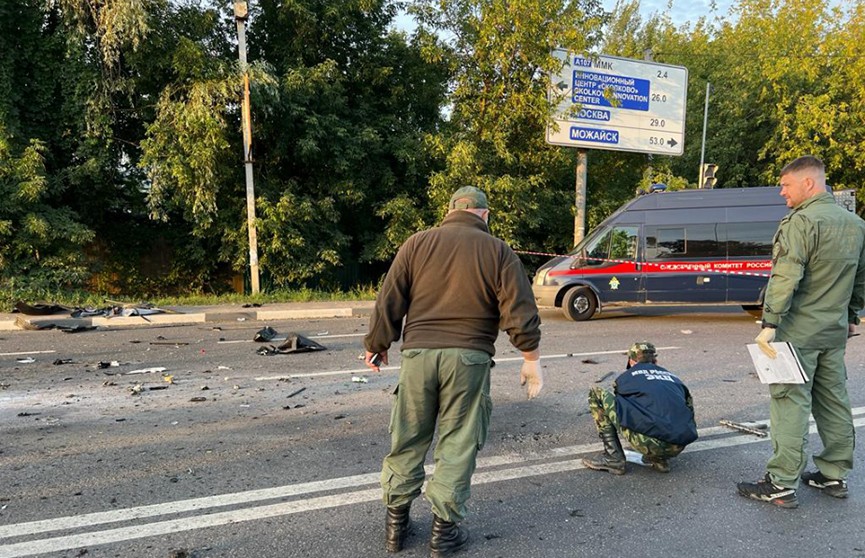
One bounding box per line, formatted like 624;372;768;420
364;186;543;556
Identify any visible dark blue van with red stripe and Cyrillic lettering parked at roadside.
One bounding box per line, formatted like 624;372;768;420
532;187;789;321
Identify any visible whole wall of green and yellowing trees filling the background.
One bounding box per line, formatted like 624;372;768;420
0;0;865;302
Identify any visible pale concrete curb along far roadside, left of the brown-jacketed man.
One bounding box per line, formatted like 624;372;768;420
0;305;372;331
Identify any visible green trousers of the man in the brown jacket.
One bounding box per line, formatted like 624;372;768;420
381;349;493;521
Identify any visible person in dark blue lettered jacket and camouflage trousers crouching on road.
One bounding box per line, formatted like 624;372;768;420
583;342;697;475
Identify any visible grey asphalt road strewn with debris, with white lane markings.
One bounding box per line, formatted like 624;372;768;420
0;308;865;558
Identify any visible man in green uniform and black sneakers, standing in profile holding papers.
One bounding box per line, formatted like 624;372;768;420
738;155;865;508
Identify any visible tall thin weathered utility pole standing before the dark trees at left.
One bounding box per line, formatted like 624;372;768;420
234;0;260;294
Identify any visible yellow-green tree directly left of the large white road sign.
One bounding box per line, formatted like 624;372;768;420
410;0;603;258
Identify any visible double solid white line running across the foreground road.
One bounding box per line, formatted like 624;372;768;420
0;407;865;558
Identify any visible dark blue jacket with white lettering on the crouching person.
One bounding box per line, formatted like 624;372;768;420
614;363;697;446
